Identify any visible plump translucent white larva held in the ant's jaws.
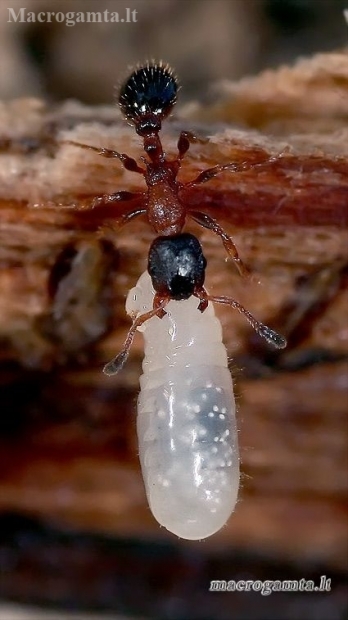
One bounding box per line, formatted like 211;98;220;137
126;272;239;540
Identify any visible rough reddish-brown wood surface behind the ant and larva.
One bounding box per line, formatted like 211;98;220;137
0;52;348;612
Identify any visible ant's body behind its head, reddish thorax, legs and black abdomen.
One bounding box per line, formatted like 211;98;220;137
63;61;272;275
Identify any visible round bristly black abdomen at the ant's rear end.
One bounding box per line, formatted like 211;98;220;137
119;63;178;123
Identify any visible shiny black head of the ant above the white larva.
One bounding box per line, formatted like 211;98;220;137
148;233;207;300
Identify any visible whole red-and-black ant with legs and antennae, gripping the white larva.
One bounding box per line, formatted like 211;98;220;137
65;62;286;374
